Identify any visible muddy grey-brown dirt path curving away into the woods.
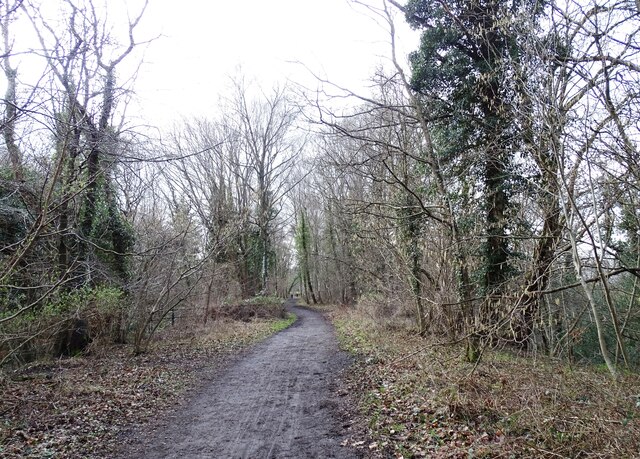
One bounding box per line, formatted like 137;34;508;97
117;303;357;459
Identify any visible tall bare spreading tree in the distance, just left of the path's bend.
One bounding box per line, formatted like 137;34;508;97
225;79;303;295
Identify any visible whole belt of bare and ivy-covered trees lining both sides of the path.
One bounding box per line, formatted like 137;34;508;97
0;0;640;424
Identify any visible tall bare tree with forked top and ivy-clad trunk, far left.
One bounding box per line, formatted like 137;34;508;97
26;1;146;283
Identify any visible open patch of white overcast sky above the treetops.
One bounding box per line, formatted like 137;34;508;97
127;0;417;125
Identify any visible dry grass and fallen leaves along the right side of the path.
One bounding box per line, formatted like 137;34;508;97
331;309;640;458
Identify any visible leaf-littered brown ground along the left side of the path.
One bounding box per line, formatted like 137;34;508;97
0;306;298;459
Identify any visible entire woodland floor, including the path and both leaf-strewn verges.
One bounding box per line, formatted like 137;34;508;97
0;304;640;459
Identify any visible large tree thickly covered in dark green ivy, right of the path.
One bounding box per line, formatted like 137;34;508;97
403;0;540;335
